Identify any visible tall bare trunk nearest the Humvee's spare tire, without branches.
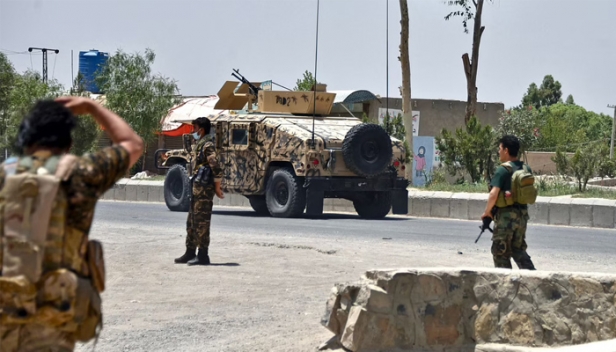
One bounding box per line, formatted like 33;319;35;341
398;0;413;182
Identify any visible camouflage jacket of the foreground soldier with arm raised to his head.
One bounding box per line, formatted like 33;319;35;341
0;146;129;274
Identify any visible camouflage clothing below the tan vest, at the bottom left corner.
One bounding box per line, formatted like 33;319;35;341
0;324;75;352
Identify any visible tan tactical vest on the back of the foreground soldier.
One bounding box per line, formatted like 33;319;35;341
0;152;105;342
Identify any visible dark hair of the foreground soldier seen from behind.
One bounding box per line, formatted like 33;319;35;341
16;100;77;152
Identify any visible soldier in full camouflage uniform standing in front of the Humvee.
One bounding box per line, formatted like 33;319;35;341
175;117;224;265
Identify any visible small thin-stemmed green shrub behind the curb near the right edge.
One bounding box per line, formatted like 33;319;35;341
552;142;614;192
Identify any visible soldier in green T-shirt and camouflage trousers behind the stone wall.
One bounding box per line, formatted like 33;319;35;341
481;135;535;270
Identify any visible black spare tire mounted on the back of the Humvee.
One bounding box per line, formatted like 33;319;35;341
342;123;393;177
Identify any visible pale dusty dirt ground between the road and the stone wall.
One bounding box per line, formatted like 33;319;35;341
77;202;616;352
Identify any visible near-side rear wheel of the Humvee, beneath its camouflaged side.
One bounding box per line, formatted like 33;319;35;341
265;169;306;218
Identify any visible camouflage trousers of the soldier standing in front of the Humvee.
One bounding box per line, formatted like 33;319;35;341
186;184;216;249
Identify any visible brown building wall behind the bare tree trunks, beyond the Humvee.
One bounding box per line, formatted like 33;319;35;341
368;98;505;137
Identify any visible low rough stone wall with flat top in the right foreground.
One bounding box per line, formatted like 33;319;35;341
322;268;616;351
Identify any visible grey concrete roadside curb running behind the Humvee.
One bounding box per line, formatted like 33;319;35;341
101;179;616;229
